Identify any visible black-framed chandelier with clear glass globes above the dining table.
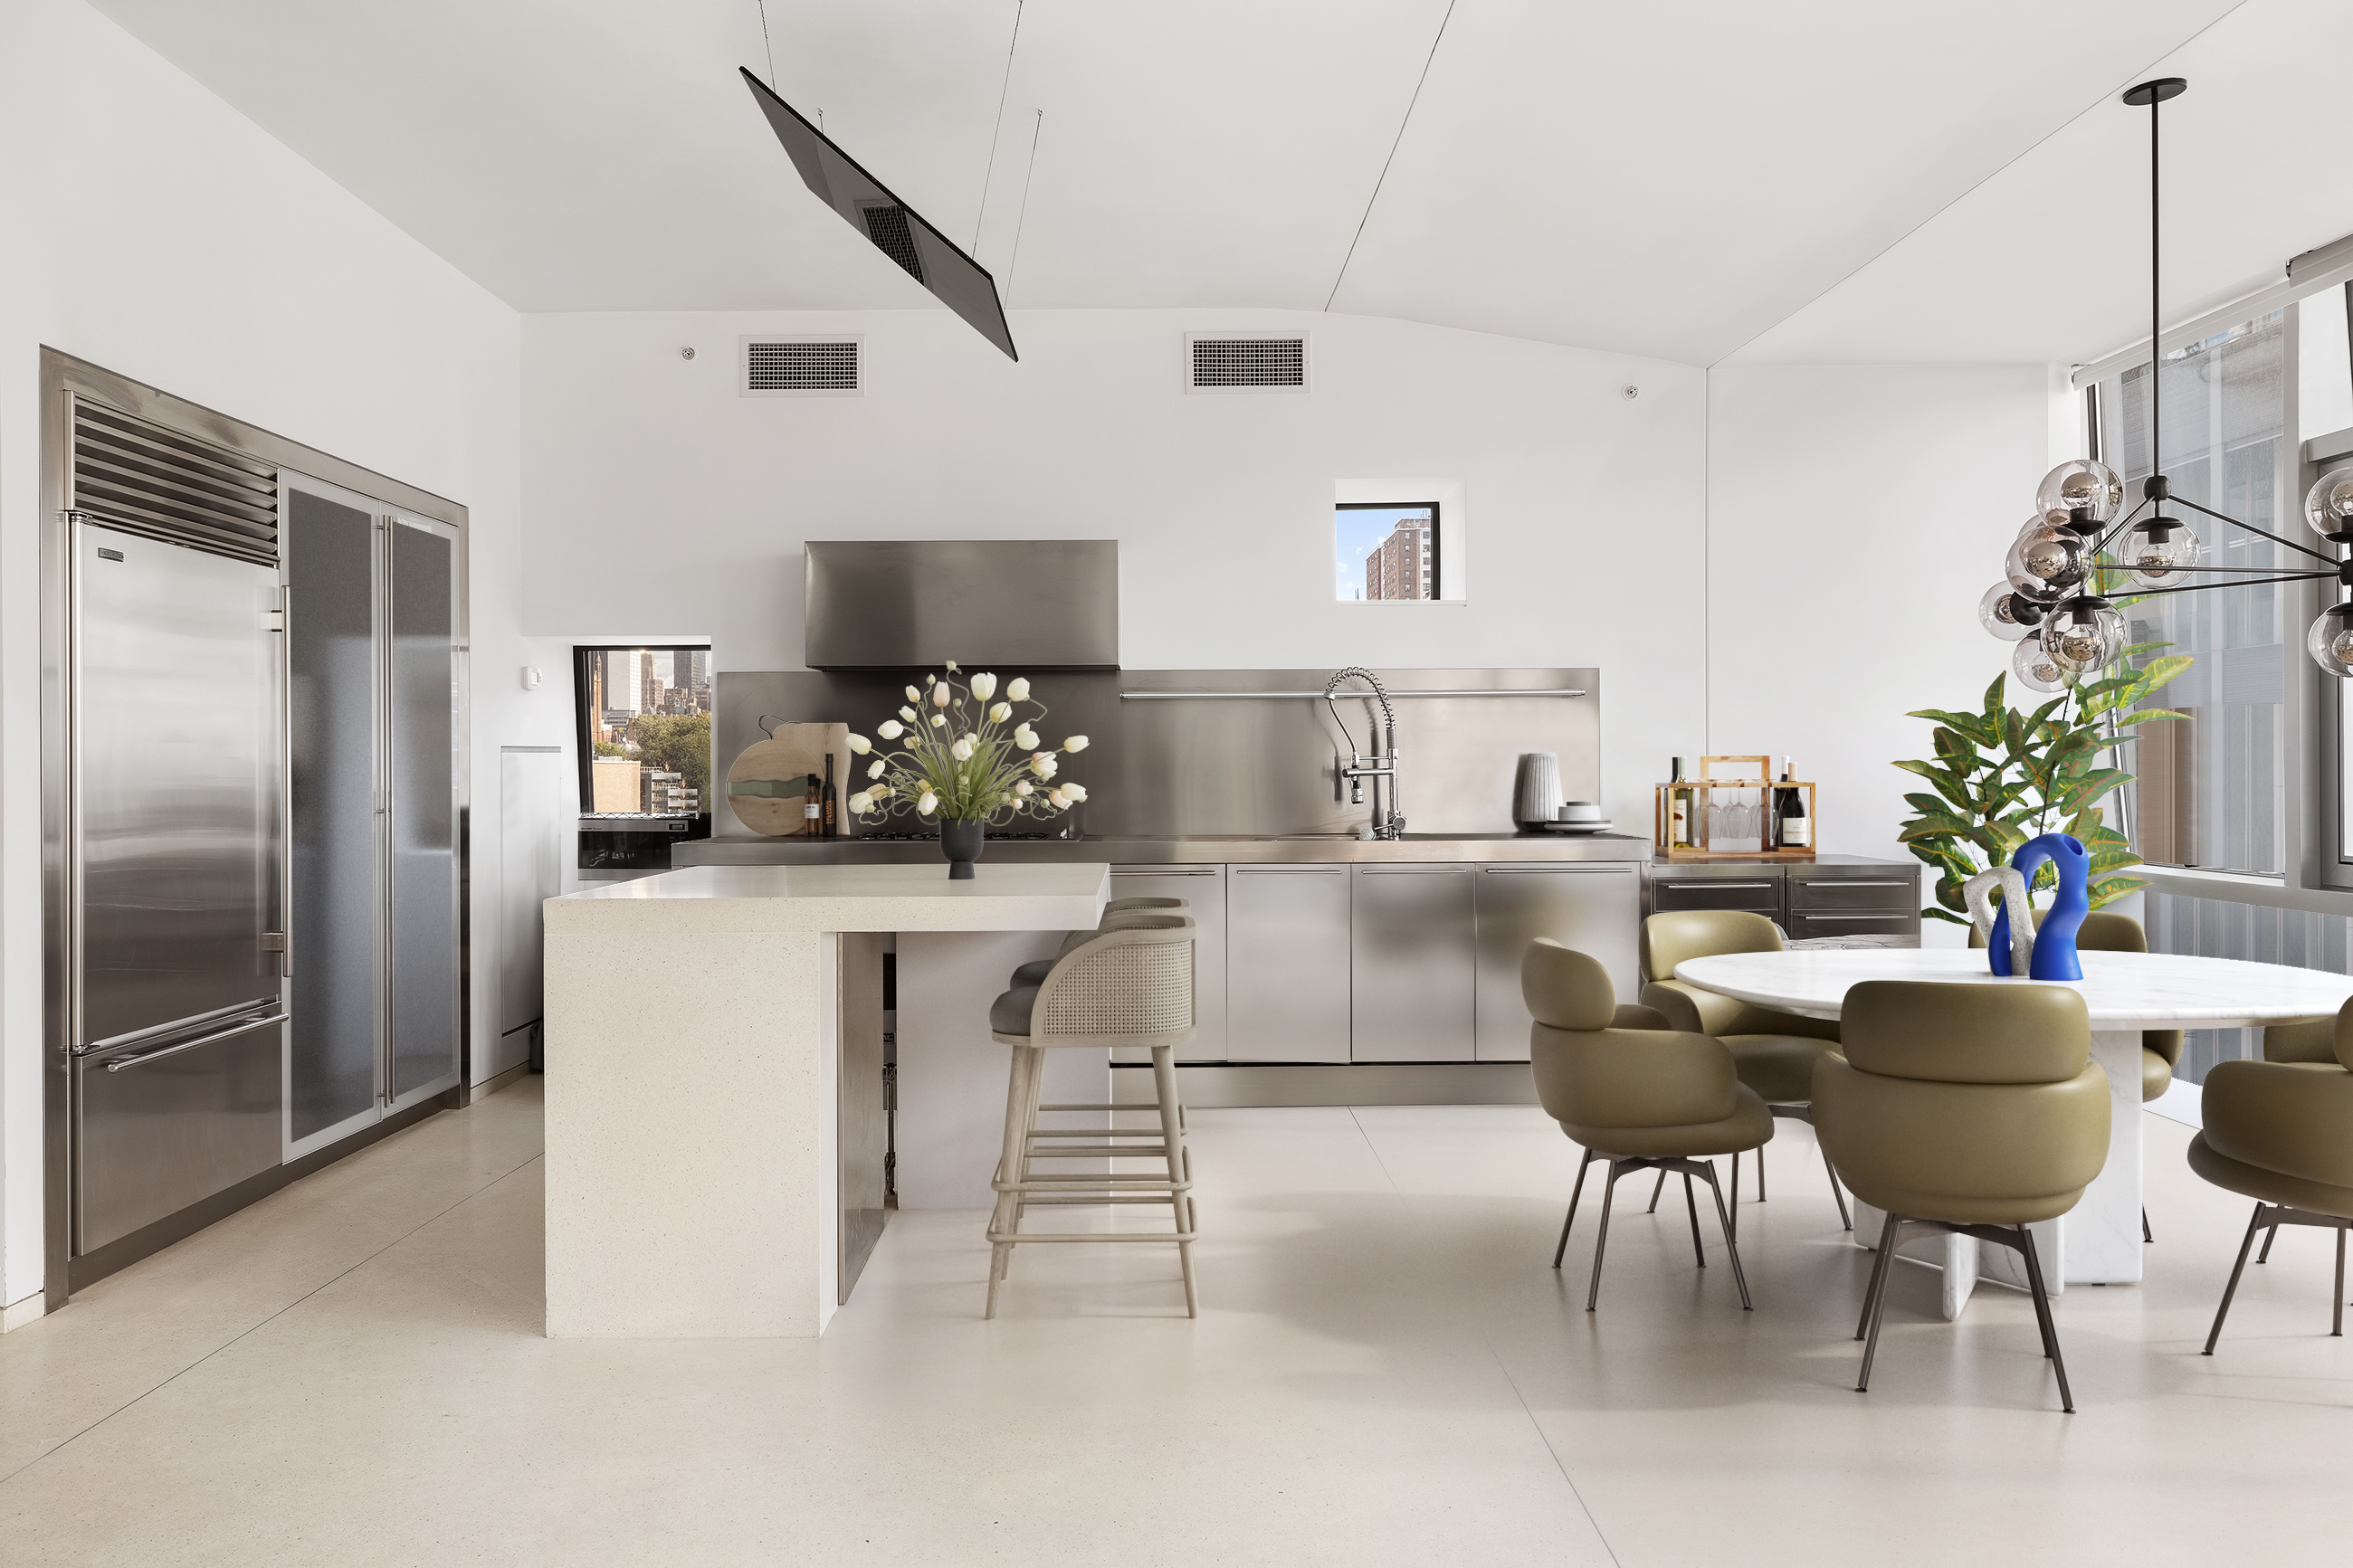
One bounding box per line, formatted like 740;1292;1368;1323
1977;75;2353;693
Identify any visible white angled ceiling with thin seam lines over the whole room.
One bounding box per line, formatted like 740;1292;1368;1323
94;0;2353;365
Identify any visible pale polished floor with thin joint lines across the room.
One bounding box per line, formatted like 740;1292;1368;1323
0;1081;2353;1568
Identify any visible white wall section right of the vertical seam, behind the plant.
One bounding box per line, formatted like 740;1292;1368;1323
1709;365;2073;940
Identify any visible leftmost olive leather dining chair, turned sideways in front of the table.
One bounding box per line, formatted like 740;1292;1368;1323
1520;936;1772;1312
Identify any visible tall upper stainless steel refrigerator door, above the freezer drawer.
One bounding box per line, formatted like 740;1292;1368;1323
73;524;280;1046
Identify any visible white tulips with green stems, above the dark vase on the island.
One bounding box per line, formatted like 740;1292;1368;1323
850;660;1087;822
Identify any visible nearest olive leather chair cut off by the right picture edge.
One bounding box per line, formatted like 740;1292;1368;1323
2191;1002;2353;1356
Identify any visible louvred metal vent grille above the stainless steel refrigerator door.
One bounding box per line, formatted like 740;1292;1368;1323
73;397;278;566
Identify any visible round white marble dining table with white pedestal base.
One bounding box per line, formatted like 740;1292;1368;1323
1675;947;2353;1319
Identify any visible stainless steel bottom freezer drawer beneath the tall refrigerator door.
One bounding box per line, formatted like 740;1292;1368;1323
73;1022;282;1253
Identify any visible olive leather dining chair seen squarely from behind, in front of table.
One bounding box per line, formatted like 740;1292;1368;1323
1815;980;2109;1411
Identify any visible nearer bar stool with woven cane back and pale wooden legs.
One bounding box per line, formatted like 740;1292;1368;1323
986;912;1200;1316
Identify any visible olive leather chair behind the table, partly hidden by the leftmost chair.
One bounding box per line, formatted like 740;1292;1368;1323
1643;910;1854;1230
